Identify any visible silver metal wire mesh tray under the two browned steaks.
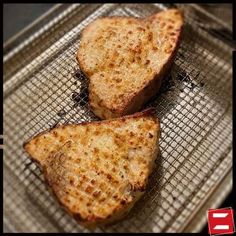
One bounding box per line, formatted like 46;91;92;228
4;5;232;232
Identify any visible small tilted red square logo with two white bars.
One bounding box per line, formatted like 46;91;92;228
207;207;235;235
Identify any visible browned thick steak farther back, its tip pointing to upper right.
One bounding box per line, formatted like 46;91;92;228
77;9;183;119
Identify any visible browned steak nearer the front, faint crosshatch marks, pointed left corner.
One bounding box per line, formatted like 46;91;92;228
24;109;160;227
